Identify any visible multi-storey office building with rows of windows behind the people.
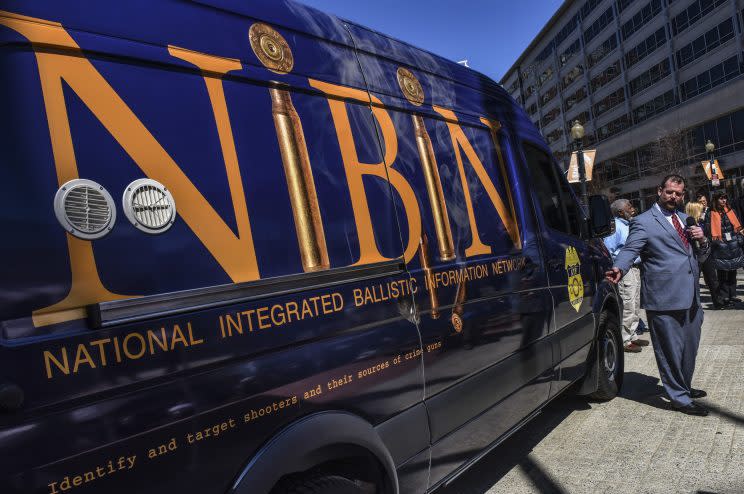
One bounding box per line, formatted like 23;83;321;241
501;0;744;208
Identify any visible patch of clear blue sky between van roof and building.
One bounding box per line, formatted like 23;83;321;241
299;0;563;81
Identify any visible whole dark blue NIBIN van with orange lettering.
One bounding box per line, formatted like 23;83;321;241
0;0;623;494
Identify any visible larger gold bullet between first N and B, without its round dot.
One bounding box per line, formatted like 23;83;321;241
269;87;331;272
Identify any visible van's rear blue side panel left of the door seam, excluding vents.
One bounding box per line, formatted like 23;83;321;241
0;1;428;494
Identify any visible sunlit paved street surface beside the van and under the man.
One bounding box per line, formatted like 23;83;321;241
446;278;744;494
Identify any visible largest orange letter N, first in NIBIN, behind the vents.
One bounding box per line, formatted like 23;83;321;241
0;11;260;326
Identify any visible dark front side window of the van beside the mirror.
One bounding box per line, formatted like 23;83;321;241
523;143;581;236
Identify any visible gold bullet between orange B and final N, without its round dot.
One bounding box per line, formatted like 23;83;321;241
412;115;455;261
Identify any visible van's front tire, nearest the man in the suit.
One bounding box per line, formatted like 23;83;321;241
589;311;624;401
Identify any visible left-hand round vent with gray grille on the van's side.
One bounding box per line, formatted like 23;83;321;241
54;178;116;240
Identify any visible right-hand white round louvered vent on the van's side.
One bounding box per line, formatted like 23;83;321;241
122;178;176;234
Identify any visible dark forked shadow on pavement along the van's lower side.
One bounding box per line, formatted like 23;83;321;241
438;396;590;494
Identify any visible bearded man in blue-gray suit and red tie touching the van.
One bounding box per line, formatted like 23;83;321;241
605;175;710;415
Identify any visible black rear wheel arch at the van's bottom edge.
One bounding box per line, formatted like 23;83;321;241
229;411;398;494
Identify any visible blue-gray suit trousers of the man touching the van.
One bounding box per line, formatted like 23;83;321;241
646;302;703;406
